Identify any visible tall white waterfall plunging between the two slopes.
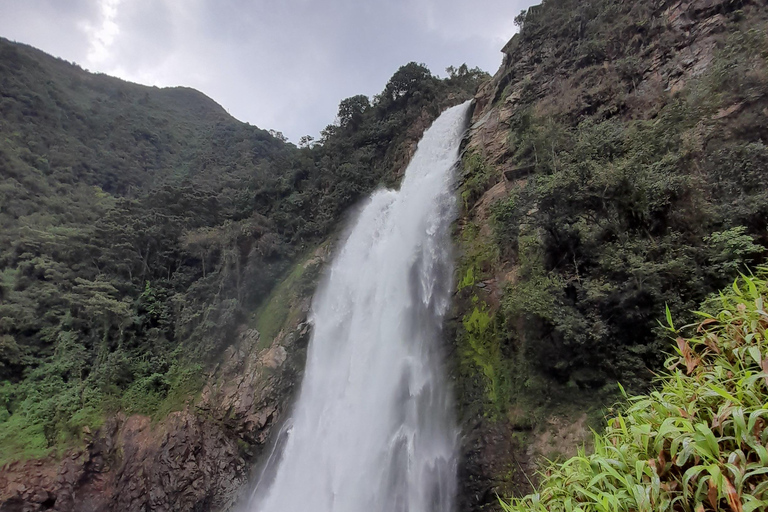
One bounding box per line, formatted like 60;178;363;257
247;102;469;512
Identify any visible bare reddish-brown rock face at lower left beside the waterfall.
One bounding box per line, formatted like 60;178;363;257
0;250;328;512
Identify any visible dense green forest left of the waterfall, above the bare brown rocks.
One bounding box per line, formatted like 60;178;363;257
0;39;480;460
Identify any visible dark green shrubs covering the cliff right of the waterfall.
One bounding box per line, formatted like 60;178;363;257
462;0;768;408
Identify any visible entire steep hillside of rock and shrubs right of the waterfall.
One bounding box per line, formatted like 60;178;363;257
455;0;768;510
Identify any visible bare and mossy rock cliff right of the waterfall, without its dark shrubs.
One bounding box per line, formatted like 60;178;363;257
454;0;768;510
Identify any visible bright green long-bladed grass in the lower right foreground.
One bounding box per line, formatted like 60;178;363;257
502;269;768;512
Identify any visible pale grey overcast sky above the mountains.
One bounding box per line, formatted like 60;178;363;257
0;0;539;142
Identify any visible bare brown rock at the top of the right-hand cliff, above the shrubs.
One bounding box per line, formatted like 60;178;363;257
469;0;740;158
